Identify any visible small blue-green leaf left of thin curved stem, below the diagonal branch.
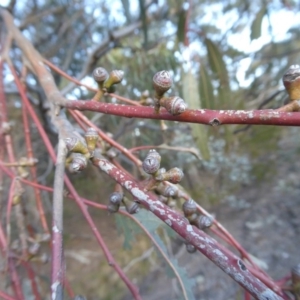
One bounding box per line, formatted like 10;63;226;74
114;214;142;250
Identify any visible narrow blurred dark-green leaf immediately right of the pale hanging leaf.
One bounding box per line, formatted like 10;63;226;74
199;64;217;109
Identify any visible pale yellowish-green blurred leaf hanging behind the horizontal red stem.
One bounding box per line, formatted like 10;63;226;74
182;70;210;160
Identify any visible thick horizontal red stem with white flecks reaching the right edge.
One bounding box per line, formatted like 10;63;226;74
64;100;300;126
